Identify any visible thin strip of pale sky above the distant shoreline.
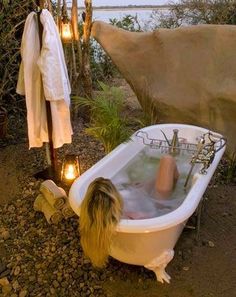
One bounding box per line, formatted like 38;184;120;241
78;0;170;6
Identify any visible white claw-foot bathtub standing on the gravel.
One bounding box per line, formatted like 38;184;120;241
69;124;225;282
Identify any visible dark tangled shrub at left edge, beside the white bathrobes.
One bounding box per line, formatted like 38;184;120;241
0;0;35;113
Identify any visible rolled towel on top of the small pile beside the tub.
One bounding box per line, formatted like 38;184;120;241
39;179;66;209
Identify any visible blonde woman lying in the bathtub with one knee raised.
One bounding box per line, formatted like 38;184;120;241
79;155;179;267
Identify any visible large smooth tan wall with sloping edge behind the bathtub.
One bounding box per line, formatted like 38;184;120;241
92;21;236;151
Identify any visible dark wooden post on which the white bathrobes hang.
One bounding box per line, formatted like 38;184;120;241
35;0;57;179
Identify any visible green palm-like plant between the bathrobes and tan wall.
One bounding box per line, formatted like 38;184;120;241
72;82;132;153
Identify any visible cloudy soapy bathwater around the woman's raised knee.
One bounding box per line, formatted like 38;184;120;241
111;146;195;219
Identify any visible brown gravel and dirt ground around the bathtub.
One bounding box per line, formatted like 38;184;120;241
0;114;236;297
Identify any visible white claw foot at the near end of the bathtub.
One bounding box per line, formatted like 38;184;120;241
144;250;174;284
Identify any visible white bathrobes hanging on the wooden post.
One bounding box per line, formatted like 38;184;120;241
16;9;72;148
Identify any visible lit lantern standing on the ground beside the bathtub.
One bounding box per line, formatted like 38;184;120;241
61;155;80;184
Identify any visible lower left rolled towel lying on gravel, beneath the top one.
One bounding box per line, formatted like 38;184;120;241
34;194;63;225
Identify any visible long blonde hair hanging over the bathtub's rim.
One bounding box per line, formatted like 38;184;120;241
79;177;123;267
